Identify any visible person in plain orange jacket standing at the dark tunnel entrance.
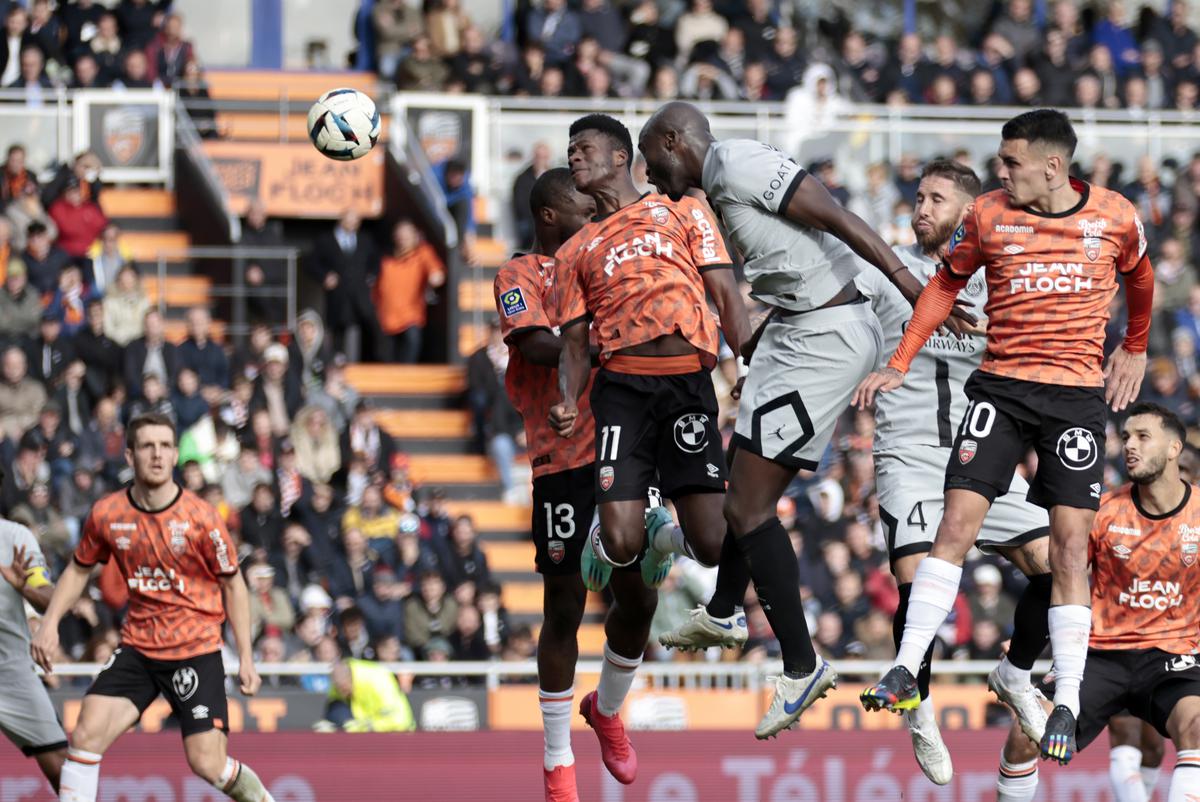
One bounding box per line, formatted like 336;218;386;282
373;220;445;364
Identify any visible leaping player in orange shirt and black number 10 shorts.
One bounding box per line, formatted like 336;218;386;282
856;109;1154;764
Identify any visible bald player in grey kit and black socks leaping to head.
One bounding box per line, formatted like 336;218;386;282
638;102;974;738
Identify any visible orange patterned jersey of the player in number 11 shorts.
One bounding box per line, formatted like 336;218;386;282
556;193;733;367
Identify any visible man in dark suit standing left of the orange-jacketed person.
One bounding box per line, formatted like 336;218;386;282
310;209;386;361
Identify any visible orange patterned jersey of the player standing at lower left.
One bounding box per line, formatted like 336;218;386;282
74;489;238;660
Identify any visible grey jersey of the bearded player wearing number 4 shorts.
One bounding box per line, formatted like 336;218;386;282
854;245;988;453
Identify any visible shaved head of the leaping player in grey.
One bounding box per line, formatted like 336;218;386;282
637;101;713;201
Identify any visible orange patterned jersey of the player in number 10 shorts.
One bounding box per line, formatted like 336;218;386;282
948;179;1148;387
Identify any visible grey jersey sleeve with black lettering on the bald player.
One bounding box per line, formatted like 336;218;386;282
704;139;808;214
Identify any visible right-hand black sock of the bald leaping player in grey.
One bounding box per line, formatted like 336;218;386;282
737;517;817;676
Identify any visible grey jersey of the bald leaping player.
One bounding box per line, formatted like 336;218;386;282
701;139;860;312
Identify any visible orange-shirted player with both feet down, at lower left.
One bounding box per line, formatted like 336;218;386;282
32;413;271;802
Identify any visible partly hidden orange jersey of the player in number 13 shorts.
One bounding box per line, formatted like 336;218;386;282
493;253;595;477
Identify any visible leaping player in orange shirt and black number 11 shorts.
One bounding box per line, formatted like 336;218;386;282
551;114;750;783
